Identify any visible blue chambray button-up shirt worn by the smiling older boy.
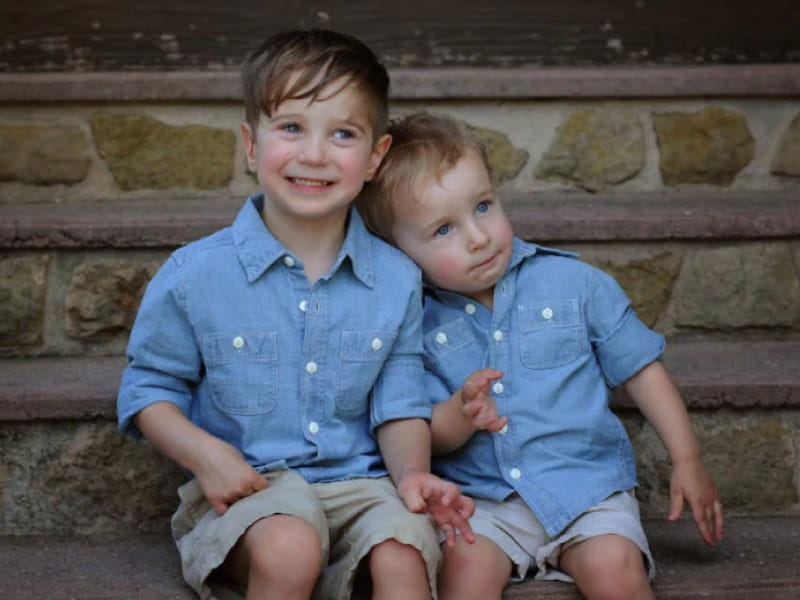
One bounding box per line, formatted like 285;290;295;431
117;196;432;483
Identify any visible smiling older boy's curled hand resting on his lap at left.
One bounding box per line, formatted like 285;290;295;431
194;438;267;515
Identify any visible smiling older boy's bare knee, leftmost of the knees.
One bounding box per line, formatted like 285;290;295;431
242;515;322;587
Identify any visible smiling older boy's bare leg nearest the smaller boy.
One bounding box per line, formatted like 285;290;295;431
368;540;431;600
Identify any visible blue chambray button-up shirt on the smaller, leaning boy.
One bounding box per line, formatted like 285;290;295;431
424;239;664;535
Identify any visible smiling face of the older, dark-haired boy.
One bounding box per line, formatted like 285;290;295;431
242;80;391;227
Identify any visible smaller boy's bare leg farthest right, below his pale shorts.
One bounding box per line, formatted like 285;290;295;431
560;534;654;600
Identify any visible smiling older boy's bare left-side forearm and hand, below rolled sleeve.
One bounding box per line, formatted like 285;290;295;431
135;402;267;514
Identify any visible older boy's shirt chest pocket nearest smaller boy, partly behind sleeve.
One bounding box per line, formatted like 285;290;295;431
336;331;397;412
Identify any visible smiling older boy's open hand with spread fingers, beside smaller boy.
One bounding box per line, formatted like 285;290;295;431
397;472;475;546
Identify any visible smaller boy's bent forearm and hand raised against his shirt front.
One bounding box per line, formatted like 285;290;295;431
431;369;508;456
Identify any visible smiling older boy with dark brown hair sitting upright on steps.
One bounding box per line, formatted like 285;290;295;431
118;31;474;600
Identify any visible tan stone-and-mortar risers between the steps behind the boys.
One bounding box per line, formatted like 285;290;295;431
0;98;800;533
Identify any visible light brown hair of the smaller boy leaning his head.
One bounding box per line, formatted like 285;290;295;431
356;112;491;244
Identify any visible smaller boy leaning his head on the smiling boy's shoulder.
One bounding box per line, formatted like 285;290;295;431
359;114;723;600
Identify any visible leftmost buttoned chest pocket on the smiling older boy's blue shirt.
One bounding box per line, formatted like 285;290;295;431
203;331;278;415
